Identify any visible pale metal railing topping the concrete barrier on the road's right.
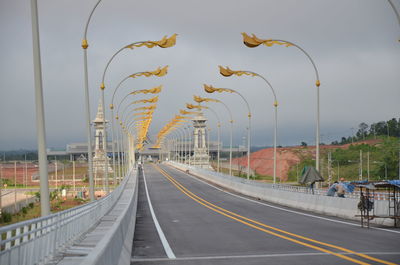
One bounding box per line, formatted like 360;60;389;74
169;161;388;200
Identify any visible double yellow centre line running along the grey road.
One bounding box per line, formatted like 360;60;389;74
153;165;395;265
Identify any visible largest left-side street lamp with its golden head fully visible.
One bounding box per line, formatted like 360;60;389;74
100;34;177;194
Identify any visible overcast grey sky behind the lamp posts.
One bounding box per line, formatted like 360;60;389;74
0;0;400;150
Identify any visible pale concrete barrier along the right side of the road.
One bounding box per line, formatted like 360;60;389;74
168;162;394;226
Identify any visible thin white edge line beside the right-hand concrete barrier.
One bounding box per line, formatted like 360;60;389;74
164;164;400;234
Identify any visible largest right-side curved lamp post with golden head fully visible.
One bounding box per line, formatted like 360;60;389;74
242;33;321;171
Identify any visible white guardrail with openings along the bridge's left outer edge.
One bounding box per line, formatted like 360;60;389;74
0;168;133;265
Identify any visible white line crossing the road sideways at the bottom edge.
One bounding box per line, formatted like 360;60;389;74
131;252;400;262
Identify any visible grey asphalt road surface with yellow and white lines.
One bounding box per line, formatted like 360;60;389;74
131;164;400;265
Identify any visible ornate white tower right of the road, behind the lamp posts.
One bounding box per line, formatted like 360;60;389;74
191;113;211;168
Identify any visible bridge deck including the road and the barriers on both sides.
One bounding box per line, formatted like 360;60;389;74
0;162;400;265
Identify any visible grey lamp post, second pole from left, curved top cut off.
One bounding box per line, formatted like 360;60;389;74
81;0;101;201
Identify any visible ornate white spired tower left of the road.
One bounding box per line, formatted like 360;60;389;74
93;101;113;174
